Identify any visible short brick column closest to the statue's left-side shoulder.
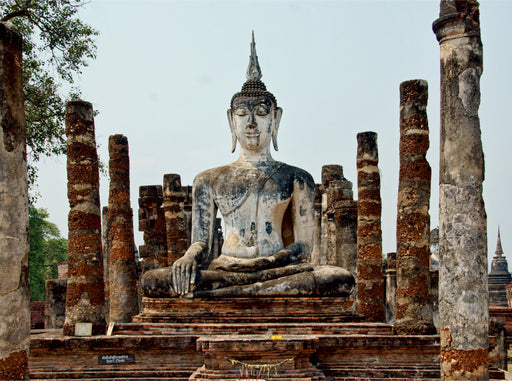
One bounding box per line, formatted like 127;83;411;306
163;173;187;266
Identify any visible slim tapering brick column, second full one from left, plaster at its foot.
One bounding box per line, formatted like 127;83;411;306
108;135;139;323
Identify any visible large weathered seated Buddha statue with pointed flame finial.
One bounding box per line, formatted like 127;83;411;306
141;35;354;297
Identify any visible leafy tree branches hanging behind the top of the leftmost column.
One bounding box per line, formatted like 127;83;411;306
0;0;98;197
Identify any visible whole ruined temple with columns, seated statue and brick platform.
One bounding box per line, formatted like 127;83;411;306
0;0;512;381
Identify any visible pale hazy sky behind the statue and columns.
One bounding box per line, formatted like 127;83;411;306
37;0;512;267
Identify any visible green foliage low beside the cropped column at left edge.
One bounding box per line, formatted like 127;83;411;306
28;205;68;301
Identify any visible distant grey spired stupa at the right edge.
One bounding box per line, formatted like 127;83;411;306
489;228;512;307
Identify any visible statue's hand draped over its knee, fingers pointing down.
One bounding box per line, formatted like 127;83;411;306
172;242;207;295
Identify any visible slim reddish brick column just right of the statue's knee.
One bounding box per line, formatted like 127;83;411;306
357;132;384;322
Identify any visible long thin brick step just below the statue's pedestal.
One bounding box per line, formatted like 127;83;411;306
113;322;392;335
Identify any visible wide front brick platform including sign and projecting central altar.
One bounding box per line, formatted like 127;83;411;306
29;323;504;381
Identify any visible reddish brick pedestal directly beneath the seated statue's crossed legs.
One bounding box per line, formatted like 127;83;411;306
133;297;362;323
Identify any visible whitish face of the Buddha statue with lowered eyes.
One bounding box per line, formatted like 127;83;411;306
228;95;282;151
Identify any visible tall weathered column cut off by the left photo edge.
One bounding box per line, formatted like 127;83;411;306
0;22;30;380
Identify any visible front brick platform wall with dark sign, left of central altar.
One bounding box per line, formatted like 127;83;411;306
29;329;204;381
